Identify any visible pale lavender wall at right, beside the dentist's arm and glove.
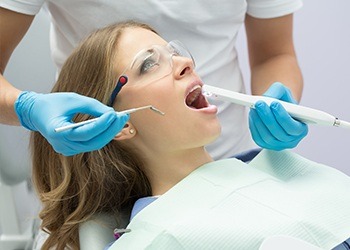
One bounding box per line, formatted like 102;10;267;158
295;0;350;172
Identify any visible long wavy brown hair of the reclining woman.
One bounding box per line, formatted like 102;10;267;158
31;22;156;249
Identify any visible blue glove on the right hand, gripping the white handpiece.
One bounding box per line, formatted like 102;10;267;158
249;82;308;151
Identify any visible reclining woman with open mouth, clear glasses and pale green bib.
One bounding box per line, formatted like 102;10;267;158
32;22;350;249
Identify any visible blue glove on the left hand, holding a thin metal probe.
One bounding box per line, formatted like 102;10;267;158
15;92;129;156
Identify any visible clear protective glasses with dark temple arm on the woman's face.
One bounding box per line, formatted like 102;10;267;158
109;40;195;106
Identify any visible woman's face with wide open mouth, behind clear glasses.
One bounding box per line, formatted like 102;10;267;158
115;28;221;151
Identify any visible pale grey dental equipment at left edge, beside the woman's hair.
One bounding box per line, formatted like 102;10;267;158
0;125;39;250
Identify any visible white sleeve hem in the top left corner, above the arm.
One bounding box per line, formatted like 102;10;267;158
0;0;45;15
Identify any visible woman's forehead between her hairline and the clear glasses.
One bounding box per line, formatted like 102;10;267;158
116;27;167;73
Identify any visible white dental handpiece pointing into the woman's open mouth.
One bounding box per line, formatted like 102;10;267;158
203;85;350;129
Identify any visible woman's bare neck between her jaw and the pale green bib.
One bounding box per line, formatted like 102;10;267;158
145;147;213;195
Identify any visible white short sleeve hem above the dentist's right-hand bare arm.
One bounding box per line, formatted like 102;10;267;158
247;0;303;18
